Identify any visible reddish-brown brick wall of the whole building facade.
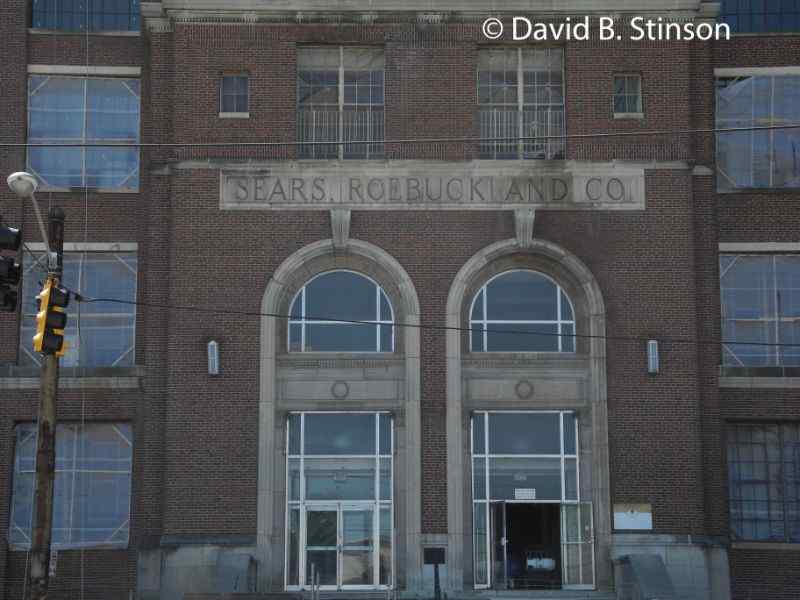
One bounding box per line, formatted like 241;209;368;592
0;0;800;600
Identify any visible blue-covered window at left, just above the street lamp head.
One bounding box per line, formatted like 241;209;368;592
28;75;139;190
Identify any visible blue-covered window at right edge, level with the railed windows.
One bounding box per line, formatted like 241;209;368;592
716;75;800;192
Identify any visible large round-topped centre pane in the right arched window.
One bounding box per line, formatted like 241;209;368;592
486;271;558;321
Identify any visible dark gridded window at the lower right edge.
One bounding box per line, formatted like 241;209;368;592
728;423;800;542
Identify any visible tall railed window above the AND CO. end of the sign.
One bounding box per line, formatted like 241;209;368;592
478;48;564;159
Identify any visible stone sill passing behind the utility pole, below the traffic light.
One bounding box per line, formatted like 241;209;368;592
0;365;145;390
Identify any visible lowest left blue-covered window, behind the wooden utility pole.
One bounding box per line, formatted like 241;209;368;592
8;423;133;549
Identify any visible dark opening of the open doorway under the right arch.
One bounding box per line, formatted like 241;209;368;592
492;503;561;590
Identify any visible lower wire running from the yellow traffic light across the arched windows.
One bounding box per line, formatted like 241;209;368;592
69;290;800;348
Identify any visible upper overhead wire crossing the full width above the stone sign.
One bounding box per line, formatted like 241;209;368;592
6;123;800;148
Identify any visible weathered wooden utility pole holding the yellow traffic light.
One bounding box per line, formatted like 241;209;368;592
28;208;64;600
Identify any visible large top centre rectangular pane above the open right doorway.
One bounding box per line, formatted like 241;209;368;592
489;413;561;454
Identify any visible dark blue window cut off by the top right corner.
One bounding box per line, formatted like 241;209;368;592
720;0;800;33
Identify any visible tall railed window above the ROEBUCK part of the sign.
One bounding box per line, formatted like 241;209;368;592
297;47;384;159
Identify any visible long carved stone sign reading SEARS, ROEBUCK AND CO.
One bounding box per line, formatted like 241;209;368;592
220;163;645;210
